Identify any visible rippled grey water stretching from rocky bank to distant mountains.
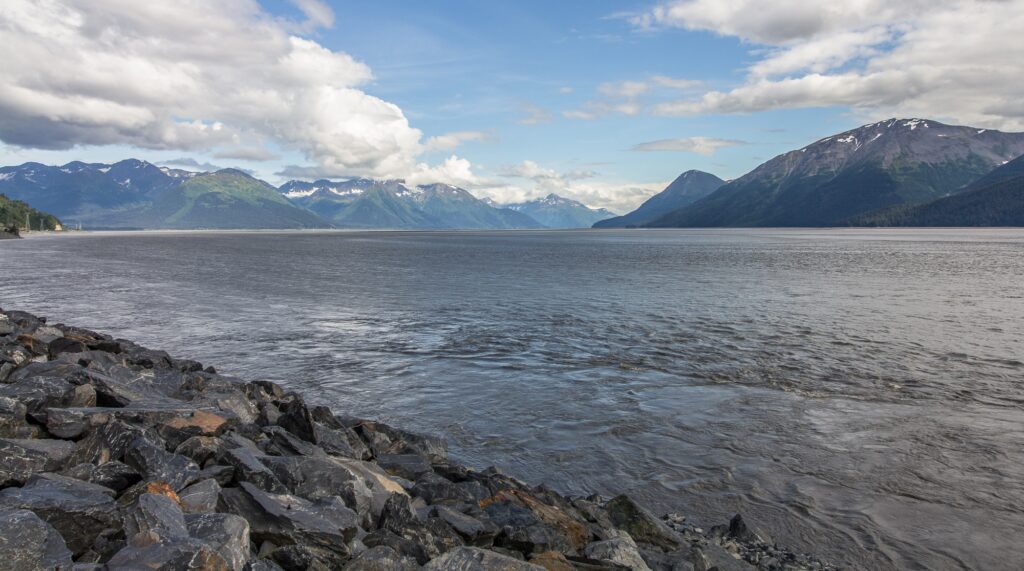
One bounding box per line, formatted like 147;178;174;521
0;229;1024;570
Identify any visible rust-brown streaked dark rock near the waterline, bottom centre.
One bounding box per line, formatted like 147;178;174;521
480;490;590;555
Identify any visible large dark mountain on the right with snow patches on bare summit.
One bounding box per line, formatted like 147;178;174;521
648;119;1024;227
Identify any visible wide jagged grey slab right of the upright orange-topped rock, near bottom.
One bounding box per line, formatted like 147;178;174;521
218;482;359;563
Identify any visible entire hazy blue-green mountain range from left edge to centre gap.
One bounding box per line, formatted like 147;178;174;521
0;159;610;229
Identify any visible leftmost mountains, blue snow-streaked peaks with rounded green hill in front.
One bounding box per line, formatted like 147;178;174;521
0;159;330;228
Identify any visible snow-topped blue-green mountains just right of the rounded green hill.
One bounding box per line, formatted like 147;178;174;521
279;178;541;229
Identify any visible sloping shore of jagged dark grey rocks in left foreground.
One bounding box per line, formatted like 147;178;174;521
0;310;835;571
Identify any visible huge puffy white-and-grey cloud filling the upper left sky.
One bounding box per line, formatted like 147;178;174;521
0;0;456;177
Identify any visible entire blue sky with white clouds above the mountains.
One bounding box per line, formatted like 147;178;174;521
0;0;1024;213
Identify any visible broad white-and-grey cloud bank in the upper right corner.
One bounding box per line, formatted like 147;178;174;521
632;0;1024;129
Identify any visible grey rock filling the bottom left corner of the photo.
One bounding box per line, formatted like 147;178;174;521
0;510;73;571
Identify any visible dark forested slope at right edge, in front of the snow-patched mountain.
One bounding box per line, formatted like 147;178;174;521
850;157;1024;226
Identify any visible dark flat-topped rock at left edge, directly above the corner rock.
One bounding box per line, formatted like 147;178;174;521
0;474;121;555
